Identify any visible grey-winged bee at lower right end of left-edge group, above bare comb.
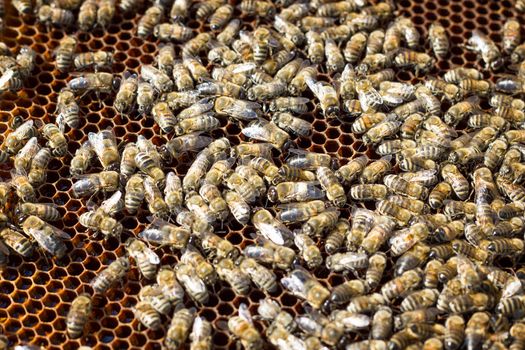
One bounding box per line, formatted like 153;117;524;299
22;215;70;259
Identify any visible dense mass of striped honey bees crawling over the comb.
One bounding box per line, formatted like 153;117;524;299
6;0;525;350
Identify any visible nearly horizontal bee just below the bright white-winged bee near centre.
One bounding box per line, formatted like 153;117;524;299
243;239;296;270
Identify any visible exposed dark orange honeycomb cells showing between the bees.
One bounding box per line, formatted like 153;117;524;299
0;0;525;349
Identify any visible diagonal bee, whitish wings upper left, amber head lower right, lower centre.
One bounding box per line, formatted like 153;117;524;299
281;269;330;309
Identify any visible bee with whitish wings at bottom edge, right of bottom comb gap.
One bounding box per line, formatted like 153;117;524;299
228;304;264;350
